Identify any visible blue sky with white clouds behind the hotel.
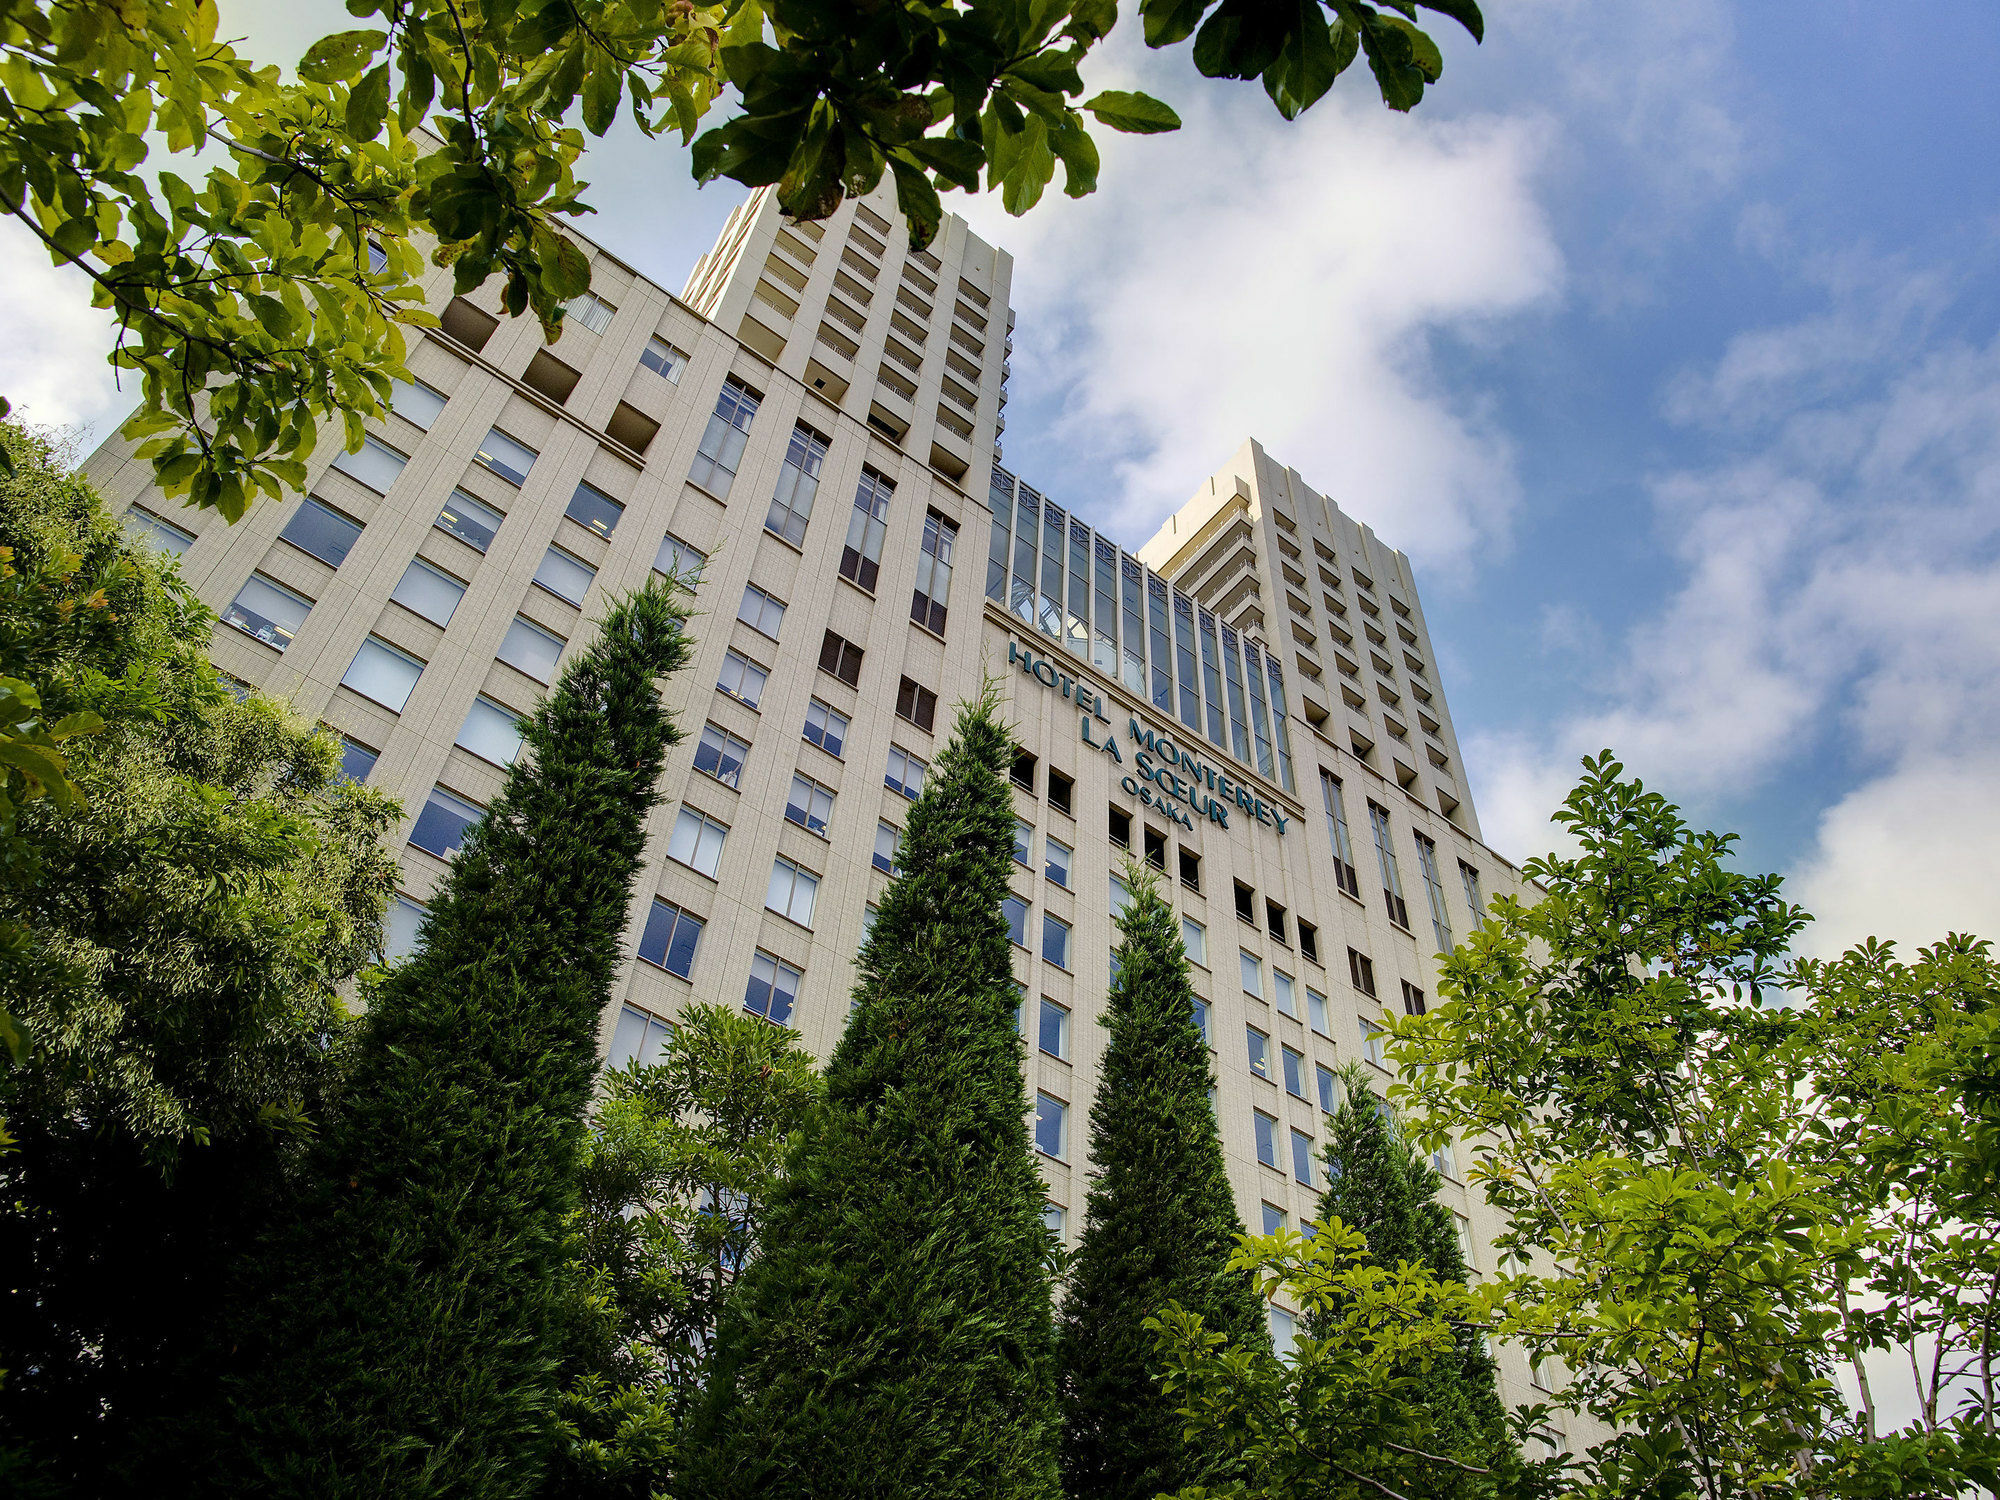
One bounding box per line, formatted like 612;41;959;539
0;0;2000;954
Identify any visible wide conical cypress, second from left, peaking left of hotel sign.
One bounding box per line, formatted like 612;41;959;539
676;684;1058;1500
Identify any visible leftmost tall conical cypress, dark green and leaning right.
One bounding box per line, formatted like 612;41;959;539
234;580;688;1500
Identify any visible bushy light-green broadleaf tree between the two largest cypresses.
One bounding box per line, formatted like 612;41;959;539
544;1004;824;1500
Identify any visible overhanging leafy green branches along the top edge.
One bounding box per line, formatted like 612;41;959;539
0;0;1484;520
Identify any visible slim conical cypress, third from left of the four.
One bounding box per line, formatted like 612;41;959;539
1056;870;1270;1500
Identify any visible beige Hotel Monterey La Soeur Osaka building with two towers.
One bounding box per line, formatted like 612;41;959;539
86;182;1560;1448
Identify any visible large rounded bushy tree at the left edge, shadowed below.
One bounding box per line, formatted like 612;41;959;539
0;426;396;1494
